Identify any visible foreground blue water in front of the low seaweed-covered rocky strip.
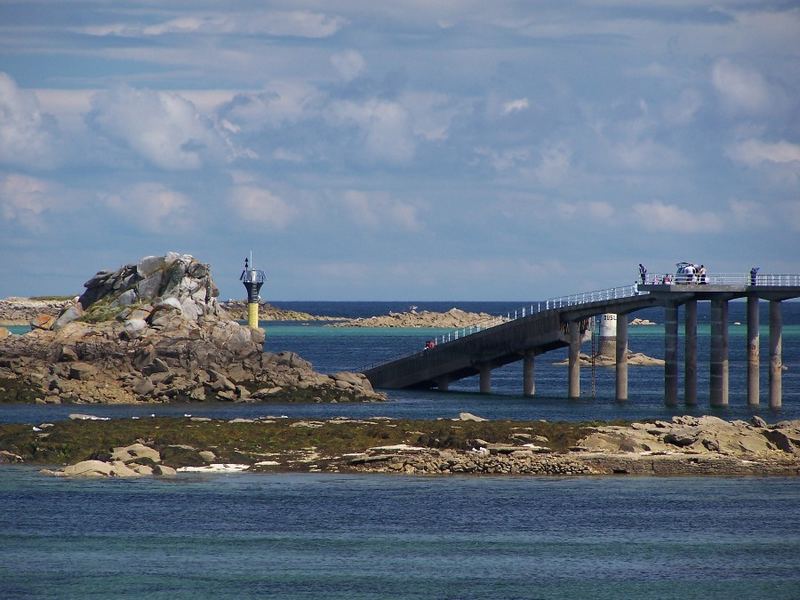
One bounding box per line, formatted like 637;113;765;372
0;467;800;600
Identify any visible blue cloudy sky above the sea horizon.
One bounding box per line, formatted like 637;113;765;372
0;0;800;301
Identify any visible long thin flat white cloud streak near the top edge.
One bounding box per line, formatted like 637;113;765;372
79;11;347;38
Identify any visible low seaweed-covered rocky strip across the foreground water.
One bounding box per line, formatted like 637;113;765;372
0;413;800;477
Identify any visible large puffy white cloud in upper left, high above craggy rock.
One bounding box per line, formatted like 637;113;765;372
89;86;236;170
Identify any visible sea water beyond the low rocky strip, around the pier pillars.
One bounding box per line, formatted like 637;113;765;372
0;302;800;423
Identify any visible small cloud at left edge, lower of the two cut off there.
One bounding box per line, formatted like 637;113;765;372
0;174;60;231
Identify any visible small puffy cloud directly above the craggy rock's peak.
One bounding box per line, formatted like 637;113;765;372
100;183;195;233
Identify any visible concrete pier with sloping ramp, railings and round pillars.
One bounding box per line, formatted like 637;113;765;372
364;275;800;408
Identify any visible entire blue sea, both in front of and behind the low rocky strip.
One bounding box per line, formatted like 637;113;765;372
0;302;800;599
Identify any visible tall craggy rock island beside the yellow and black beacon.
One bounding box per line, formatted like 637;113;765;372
0;253;385;403
